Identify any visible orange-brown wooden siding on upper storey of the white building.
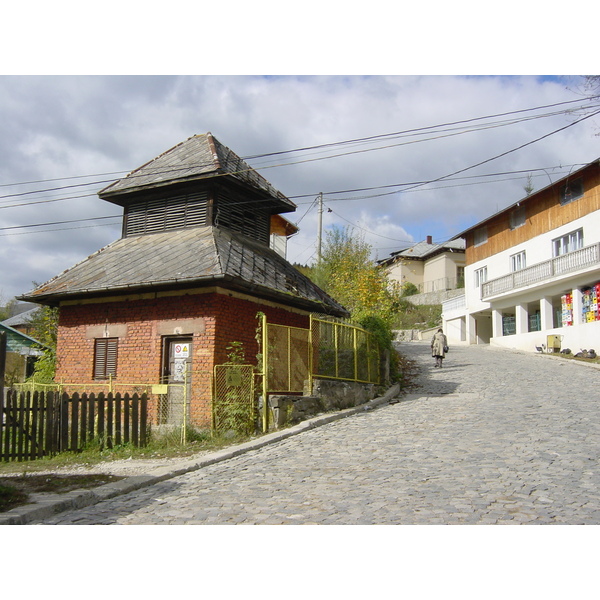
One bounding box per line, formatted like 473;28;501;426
465;162;600;265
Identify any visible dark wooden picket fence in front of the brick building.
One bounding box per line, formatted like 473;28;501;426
0;390;148;461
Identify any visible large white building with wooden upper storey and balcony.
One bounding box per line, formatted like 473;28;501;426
442;160;600;353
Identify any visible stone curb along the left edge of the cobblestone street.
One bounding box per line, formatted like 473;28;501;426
0;383;400;525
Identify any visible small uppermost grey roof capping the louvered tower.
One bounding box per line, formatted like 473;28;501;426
98;133;296;212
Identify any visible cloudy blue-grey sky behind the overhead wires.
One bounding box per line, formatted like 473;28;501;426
0;6;600;300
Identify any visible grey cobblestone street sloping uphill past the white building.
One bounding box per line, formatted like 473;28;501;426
31;342;600;524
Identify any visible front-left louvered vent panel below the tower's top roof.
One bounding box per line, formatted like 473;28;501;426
125;192;208;236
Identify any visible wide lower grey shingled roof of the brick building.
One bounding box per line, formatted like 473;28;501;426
21;227;348;316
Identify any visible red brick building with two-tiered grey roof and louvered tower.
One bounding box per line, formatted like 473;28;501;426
23;133;348;428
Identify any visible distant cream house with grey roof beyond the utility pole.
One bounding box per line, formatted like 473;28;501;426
378;236;465;293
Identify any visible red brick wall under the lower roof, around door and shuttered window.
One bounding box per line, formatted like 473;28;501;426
56;293;309;427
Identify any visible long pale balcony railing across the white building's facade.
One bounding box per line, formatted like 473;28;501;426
481;244;600;300
